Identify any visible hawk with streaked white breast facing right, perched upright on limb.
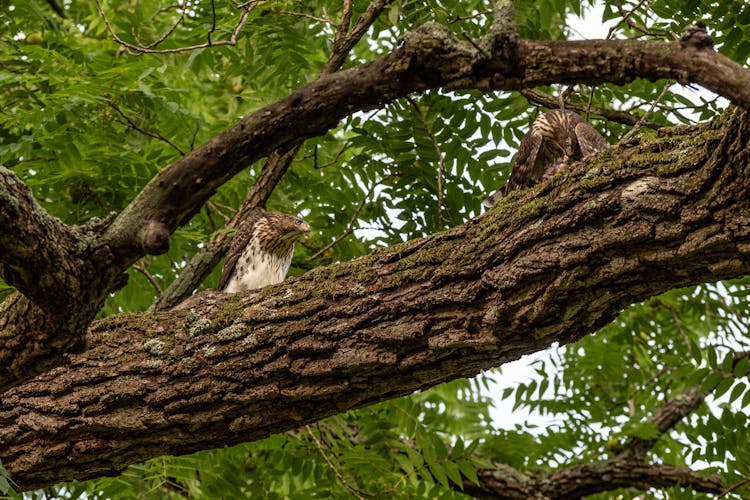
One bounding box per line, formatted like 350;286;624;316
219;210;310;293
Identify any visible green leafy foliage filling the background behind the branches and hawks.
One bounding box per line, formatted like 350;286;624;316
0;0;750;498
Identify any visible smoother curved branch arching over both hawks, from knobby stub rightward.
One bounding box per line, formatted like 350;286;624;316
106;24;750;265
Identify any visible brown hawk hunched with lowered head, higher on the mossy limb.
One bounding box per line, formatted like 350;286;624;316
482;109;609;208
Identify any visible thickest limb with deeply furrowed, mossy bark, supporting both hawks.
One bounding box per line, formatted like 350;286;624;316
0;108;750;489
